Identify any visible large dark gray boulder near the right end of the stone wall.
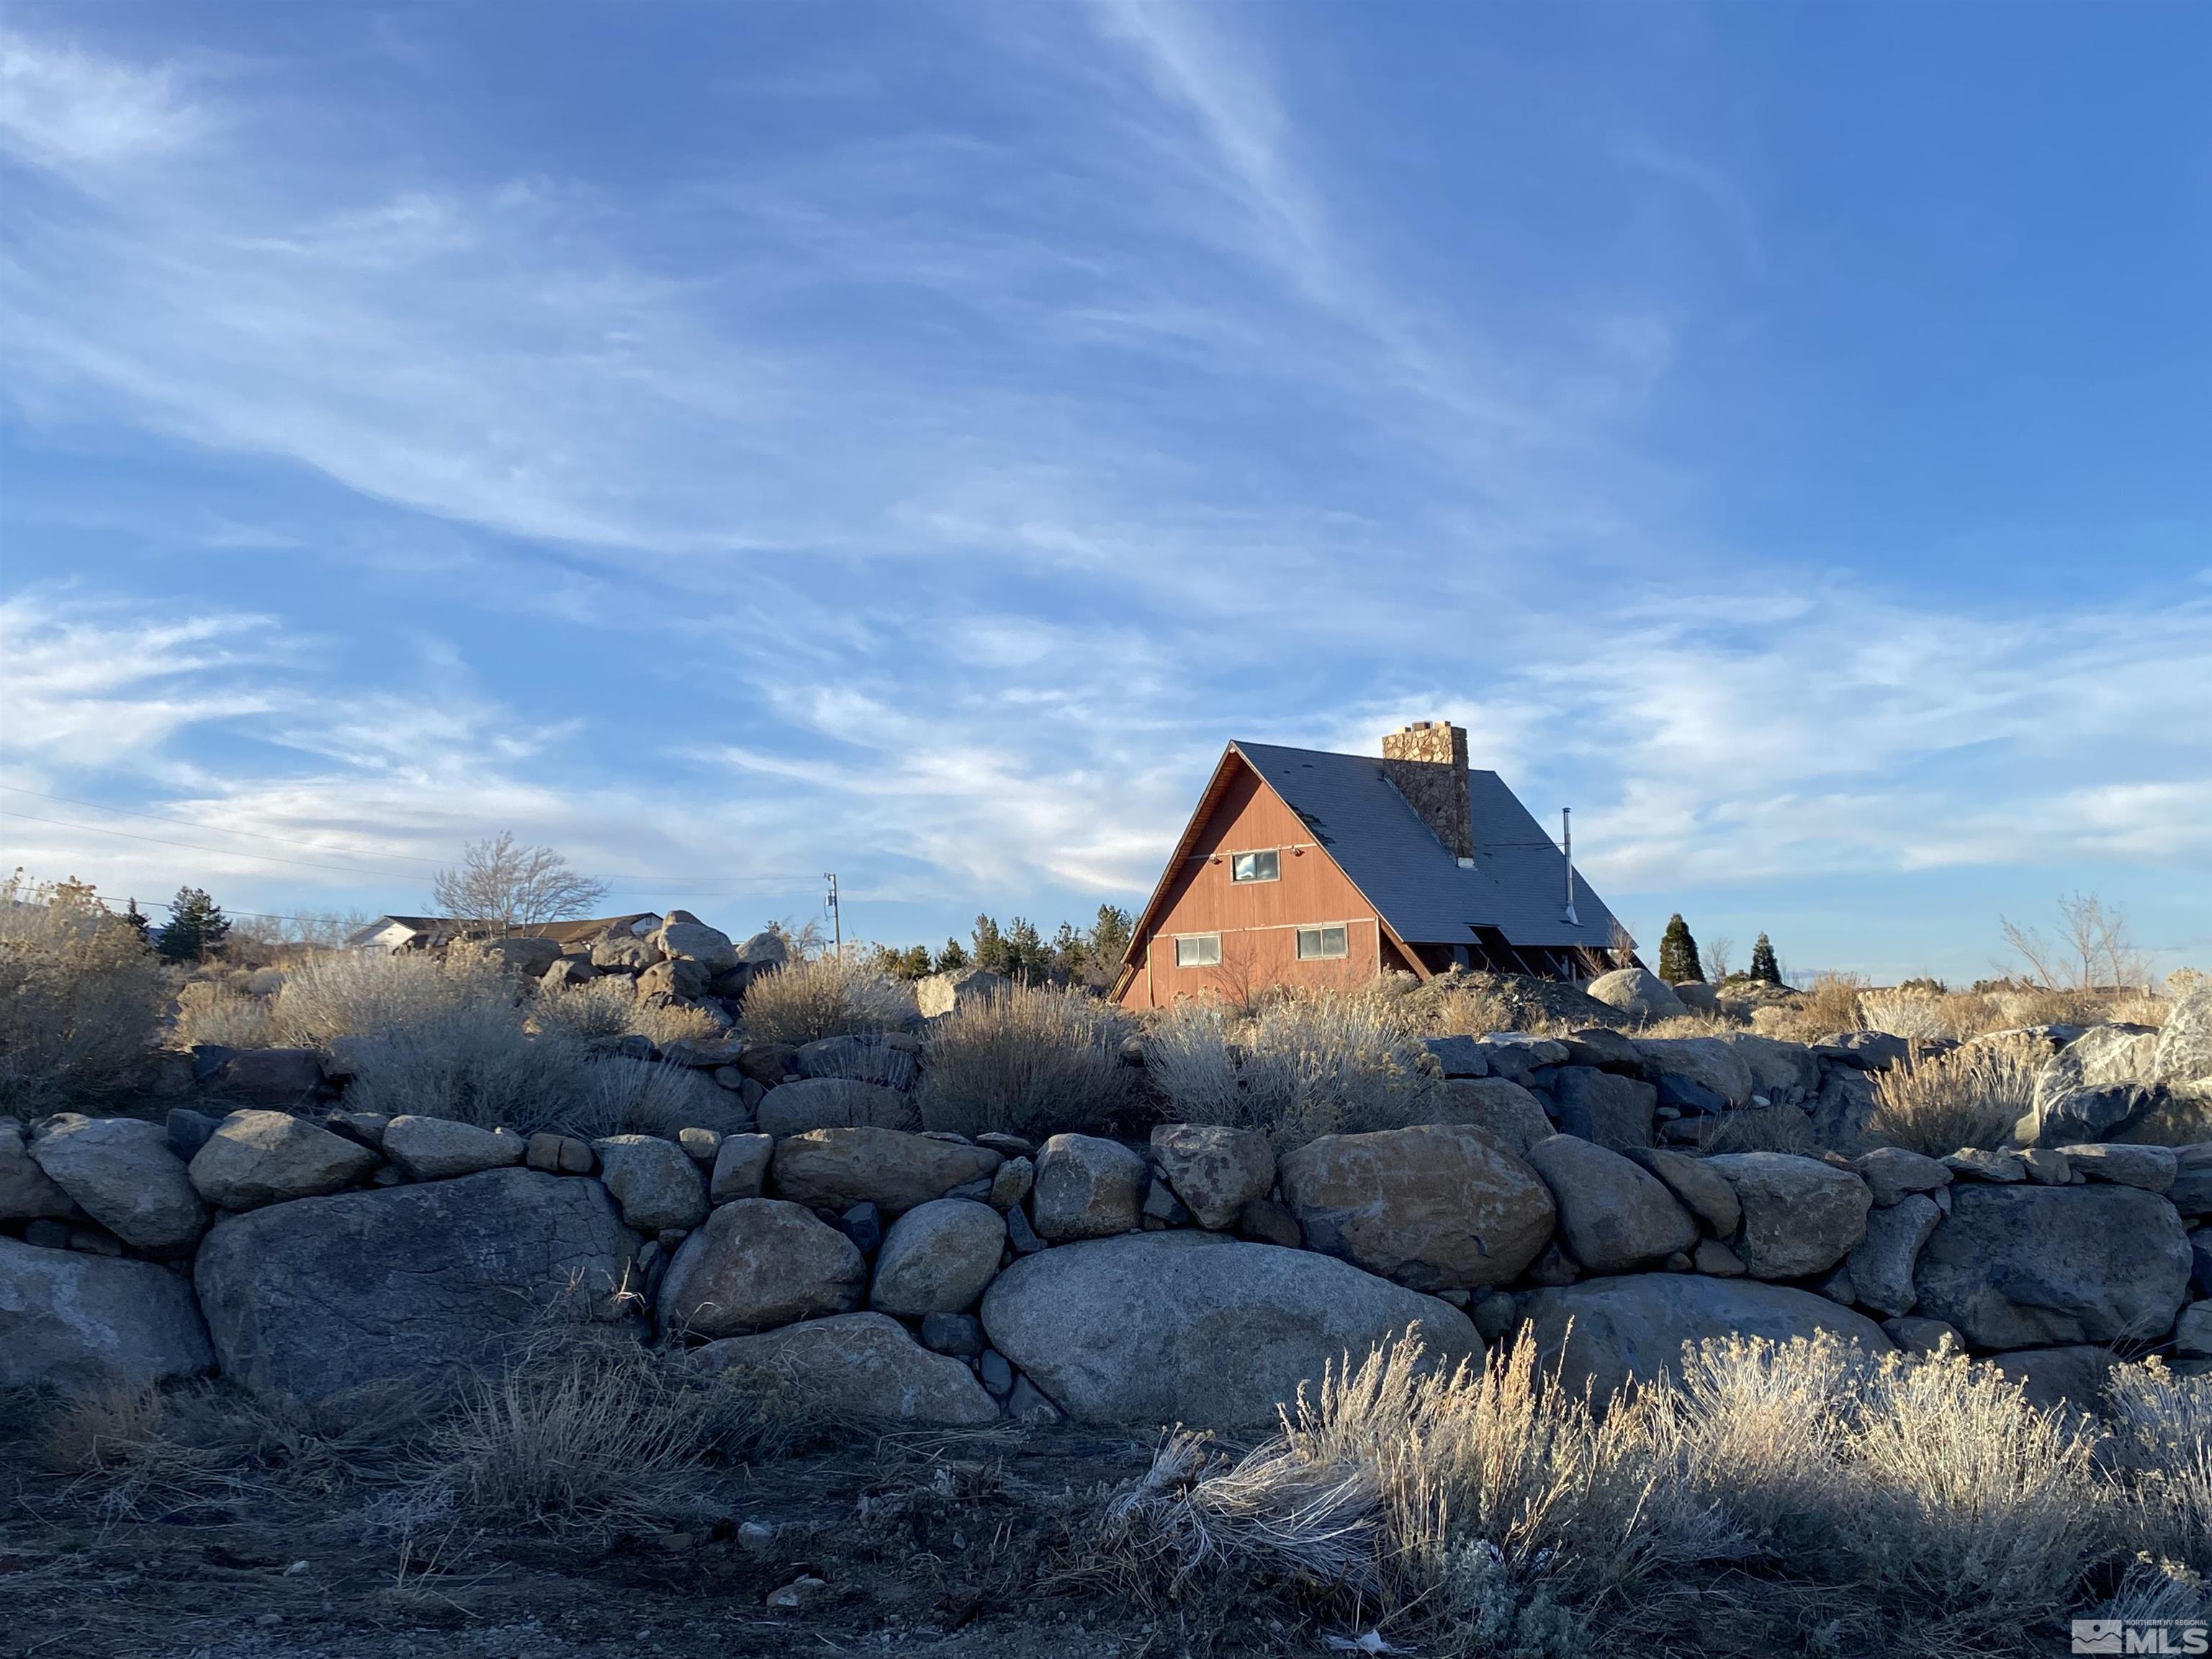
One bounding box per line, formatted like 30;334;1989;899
1913;1184;2190;1349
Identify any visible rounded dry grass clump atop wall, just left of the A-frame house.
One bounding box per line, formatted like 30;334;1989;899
918;984;1130;1139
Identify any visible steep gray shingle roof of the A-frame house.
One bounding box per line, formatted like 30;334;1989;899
1230;743;1615;949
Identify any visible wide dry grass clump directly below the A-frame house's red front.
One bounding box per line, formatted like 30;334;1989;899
1143;991;1431;1153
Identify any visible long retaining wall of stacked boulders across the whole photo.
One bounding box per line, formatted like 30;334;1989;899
0;1033;2212;1426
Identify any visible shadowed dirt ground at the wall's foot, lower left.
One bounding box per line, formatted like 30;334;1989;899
0;1424;1327;1659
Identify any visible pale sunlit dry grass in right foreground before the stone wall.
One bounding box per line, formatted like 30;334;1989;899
1097;1339;2212;1657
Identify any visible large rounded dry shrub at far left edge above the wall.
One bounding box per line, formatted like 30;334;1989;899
0;873;168;1117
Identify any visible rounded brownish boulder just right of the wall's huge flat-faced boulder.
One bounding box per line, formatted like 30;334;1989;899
659;1199;867;1336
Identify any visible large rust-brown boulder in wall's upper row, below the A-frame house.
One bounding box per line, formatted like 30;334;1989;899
1277;1124;1557;1290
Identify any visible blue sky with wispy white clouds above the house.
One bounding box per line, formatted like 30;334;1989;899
0;0;2212;982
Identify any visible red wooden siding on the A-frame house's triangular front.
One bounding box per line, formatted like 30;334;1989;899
1119;765;1407;1009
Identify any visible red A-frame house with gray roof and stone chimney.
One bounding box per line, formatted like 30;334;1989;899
1112;721;1635;1009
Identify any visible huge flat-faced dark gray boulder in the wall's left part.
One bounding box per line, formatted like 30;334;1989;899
192;1168;639;1401
